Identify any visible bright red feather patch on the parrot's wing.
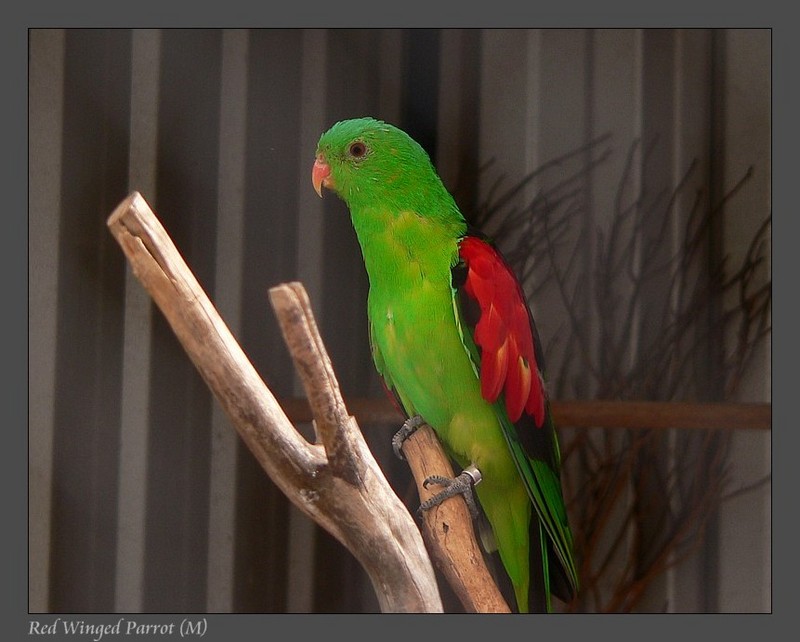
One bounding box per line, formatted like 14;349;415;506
459;236;545;426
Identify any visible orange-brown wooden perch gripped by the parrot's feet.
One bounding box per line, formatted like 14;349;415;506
396;425;510;613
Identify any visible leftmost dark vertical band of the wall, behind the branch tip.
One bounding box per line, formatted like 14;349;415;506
49;30;131;611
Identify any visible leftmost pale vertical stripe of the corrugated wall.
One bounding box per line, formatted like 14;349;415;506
28;30;64;612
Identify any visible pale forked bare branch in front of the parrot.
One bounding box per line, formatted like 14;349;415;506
108;192;442;612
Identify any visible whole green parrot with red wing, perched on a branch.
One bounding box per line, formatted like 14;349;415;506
312;118;578;612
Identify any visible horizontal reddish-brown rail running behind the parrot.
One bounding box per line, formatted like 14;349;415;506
280;397;772;430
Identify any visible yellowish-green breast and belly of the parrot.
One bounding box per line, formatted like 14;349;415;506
354;208;506;463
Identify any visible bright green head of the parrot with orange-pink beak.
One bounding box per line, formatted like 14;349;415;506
311;118;449;210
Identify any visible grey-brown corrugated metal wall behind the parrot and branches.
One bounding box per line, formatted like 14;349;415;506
29;29;771;613
